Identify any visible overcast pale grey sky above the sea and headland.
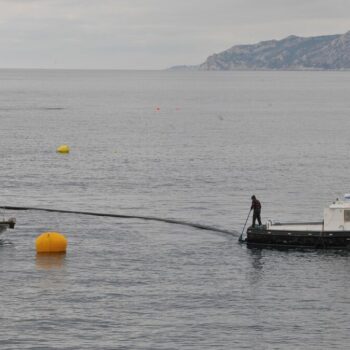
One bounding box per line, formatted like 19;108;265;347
0;0;350;69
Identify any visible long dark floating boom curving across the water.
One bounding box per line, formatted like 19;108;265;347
0;206;238;235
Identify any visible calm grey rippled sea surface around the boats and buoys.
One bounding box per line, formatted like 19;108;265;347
0;70;350;350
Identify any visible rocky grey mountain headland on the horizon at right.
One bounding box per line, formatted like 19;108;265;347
173;31;350;71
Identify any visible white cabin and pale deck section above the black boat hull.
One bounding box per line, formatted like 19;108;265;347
266;194;350;232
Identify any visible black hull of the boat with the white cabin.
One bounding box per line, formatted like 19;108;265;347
246;226;350;249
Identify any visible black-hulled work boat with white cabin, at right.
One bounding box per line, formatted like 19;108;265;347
245;194;350;249
